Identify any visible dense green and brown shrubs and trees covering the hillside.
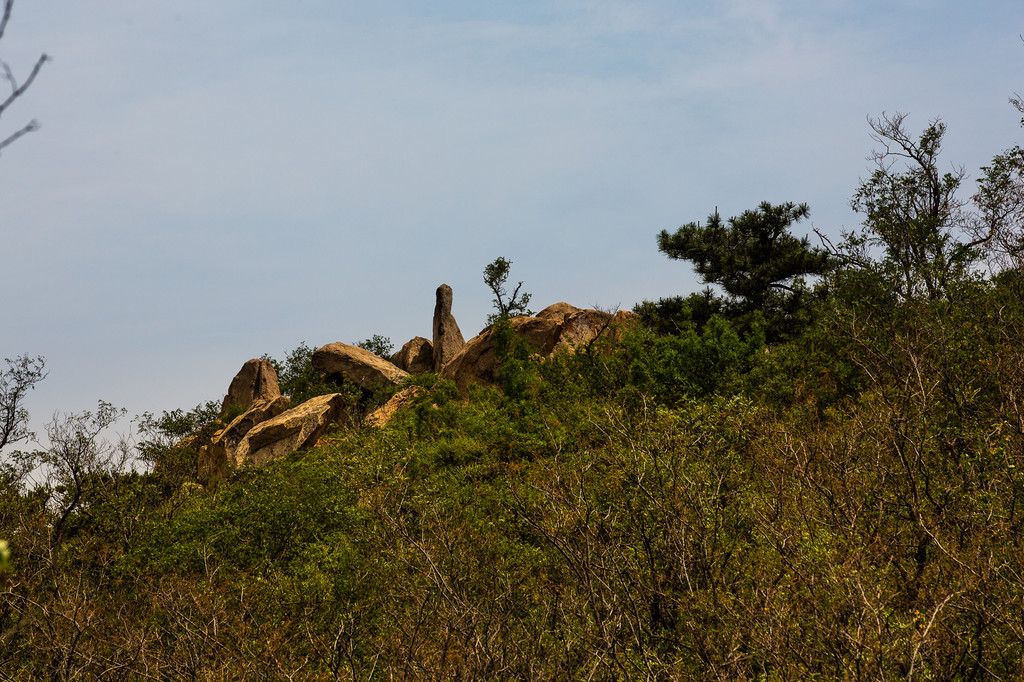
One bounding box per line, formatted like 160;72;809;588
6;111;1024;680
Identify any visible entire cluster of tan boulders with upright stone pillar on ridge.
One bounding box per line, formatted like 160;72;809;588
199;296;636;473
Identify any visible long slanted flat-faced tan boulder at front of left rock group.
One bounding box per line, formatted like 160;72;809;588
233;393;345;467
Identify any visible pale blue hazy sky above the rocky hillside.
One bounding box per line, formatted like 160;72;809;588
0;0;1024;430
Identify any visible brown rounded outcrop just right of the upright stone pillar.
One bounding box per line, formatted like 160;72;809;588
439;303;636;395
